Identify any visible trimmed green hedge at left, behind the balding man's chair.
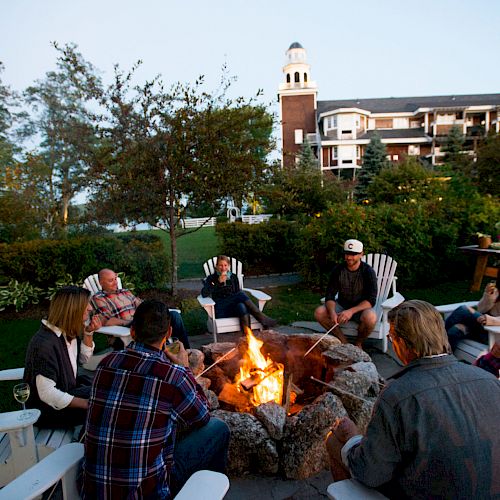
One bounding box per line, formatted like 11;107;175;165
0;232;169;291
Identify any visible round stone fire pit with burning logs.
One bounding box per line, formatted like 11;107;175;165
190;331;379;479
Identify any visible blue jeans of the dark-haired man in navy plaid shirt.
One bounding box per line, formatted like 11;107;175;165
170;417;230;498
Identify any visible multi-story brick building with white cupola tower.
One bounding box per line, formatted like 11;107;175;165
278;42;500;178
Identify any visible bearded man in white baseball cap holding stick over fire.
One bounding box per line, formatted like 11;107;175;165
314;239;377;347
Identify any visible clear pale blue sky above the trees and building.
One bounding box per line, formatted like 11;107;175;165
0;0;500;110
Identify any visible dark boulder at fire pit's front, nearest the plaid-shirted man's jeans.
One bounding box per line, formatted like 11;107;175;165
212;410;279;475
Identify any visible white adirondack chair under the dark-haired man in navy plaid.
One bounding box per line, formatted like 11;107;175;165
0;443;229;500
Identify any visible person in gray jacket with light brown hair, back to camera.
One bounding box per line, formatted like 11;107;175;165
326;300;500;499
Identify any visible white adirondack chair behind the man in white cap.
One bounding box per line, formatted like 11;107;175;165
321;253;405;352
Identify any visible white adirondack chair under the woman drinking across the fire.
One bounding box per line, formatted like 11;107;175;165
198;257;271;342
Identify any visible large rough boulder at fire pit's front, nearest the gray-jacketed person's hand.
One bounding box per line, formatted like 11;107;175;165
280;392;347;479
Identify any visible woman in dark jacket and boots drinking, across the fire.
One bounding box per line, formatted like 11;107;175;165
201;255;277;333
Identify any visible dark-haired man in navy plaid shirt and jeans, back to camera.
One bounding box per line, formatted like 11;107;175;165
82;300;229;499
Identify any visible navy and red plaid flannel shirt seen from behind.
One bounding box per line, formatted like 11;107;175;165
82;342;210;499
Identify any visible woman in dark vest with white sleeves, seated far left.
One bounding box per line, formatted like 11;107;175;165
24;286;101;427
